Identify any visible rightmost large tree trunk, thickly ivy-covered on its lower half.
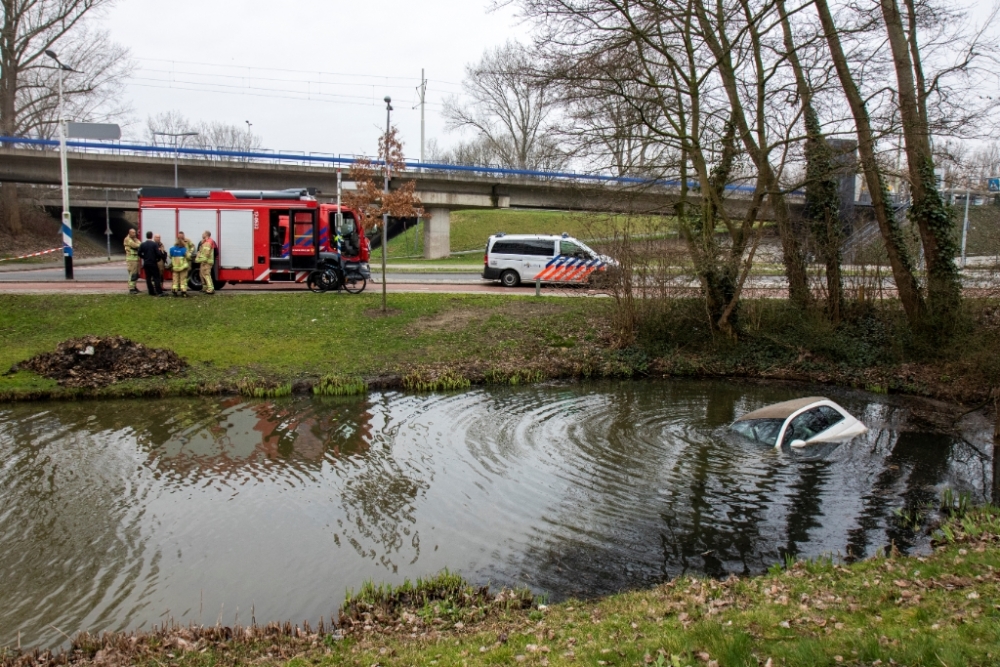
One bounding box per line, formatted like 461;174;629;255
880;0;962;321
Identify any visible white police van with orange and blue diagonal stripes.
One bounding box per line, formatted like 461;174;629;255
483;234;618;287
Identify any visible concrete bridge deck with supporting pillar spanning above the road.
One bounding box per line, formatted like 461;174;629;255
0;142;800;259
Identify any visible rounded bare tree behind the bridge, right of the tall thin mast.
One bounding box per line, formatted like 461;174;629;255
444;42;567;169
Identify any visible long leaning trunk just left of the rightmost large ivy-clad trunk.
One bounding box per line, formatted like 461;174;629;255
813;0;924;326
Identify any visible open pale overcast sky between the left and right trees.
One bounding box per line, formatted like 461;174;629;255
99;0;526;159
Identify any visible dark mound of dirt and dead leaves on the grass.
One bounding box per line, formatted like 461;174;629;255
11;336;187;388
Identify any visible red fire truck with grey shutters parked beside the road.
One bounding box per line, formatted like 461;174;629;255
139;188;371;292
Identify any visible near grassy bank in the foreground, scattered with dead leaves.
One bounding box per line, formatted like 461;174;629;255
0;508;1000;667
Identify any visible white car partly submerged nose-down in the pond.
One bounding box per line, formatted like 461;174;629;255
731;396;868;447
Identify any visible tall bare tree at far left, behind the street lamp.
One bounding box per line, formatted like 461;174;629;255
0;0;132;235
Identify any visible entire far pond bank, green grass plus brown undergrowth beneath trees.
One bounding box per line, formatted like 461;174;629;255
0;292;1000;404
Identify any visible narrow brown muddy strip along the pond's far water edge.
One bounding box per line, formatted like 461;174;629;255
0;350;992;406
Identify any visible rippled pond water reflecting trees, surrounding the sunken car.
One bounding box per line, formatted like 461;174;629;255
0;381;990;646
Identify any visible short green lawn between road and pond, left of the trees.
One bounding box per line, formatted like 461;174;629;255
0;292;609;399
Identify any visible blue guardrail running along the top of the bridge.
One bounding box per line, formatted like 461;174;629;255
0;136;755;193
